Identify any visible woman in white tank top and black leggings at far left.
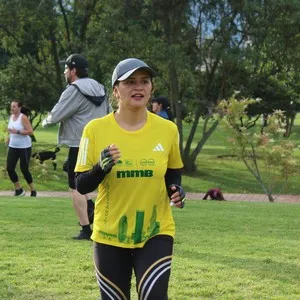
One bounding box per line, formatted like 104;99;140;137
6;100;36;197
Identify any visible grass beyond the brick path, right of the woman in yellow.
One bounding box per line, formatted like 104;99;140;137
183;116;300;195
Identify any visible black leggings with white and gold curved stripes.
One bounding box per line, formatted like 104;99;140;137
94;235;173;300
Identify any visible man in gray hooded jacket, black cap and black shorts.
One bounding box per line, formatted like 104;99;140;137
42;54;111;240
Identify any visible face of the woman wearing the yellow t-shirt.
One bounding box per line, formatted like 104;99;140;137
114;70;152;109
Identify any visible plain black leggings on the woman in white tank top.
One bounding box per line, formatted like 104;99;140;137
6;147;32;184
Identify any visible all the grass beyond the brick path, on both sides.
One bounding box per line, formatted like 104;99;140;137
0;116;300;194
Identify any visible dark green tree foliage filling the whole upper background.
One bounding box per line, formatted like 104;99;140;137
0;0;300;172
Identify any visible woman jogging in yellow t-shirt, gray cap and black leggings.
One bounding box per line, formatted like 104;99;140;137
75;58;185;300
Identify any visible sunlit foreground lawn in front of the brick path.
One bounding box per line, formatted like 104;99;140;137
0;197;300;300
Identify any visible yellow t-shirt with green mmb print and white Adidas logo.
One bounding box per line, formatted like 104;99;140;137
75;112;183;248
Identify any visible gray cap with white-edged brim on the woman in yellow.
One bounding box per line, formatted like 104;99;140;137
111;58;156;87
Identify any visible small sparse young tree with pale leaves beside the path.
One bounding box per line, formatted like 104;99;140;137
215;93;299;202
